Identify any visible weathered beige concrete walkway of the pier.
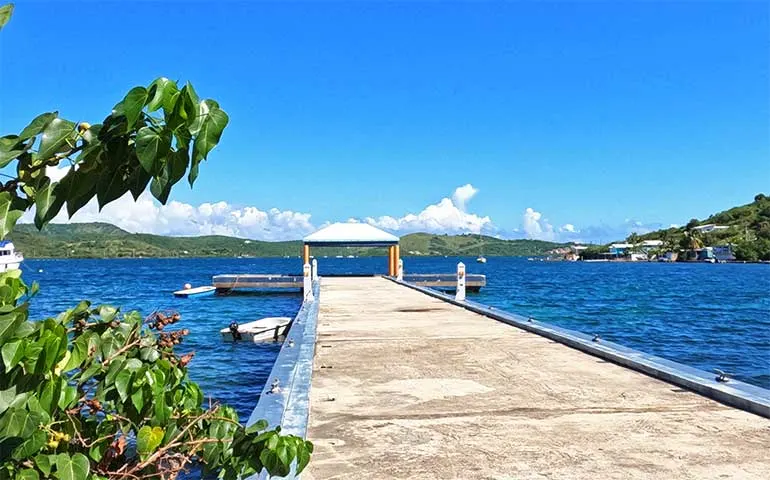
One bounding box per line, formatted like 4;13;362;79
302;278;770;480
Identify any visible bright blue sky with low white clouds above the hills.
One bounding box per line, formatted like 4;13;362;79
0;1;770;241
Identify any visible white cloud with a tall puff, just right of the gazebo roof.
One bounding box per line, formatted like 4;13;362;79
364;184;495;233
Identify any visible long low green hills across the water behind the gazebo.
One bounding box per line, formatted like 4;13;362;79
10;223;563;258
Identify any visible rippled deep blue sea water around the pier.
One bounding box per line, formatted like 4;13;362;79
23;257;770;419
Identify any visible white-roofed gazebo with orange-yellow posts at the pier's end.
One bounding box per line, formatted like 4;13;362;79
302;223;401;276
